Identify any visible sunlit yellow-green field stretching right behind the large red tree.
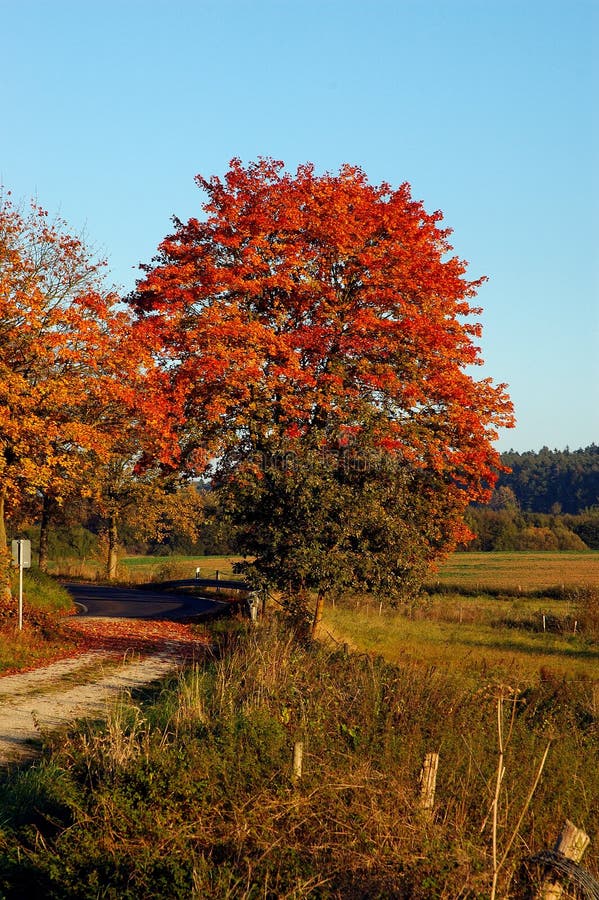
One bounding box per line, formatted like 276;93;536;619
324;551;599;684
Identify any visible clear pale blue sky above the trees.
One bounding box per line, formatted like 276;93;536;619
0;0;599;450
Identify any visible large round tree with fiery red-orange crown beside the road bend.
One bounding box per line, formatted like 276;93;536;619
131;159;512;628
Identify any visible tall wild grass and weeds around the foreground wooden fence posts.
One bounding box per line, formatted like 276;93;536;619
0;620;599;900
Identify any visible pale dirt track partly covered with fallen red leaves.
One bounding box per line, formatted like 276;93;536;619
0;619;211;765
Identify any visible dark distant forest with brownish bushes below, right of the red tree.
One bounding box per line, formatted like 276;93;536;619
461;444;599;550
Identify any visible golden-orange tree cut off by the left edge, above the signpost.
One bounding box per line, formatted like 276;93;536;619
0;197;176;594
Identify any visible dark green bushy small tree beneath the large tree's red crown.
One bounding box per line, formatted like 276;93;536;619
220;431;468;634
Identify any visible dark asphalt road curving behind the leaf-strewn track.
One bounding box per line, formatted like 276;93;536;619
63;581;228;619
